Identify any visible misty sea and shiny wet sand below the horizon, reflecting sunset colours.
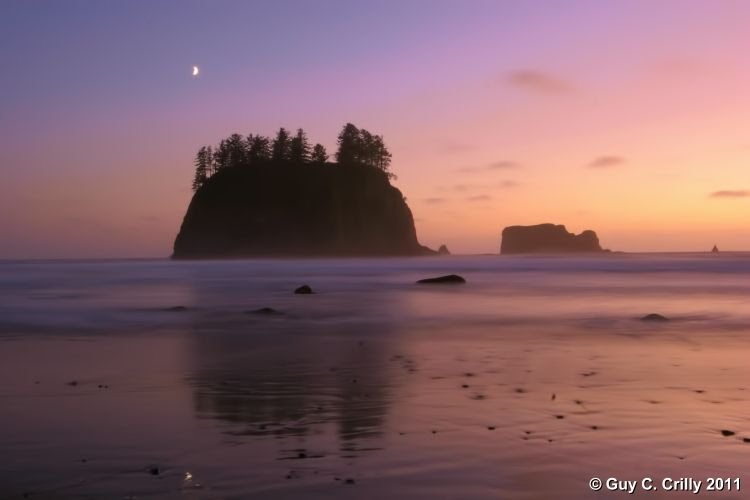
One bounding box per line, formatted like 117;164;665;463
0;253;750;498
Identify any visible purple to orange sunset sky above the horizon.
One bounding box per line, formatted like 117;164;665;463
0;0;750;259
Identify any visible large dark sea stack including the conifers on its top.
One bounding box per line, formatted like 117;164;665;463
173;124;433;258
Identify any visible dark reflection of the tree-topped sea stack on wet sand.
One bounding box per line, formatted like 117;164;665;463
188;317;393;457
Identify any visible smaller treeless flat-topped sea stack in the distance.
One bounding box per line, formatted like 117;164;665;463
500;224;605;254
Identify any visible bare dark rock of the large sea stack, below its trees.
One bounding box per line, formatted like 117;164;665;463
173;163;433;258
